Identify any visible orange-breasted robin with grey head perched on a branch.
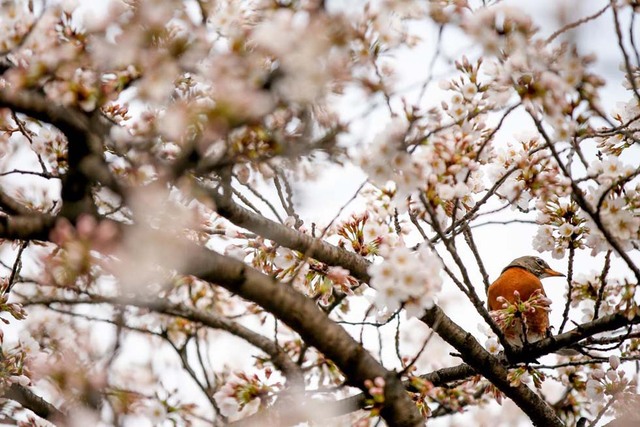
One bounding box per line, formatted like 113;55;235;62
487;256;564;346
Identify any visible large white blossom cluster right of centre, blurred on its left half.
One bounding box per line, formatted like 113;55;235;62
359;58;497;219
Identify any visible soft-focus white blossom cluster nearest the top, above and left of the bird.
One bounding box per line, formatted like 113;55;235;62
463;5;604;134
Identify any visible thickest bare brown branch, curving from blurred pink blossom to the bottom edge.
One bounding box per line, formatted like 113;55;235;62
185;247;424;426
